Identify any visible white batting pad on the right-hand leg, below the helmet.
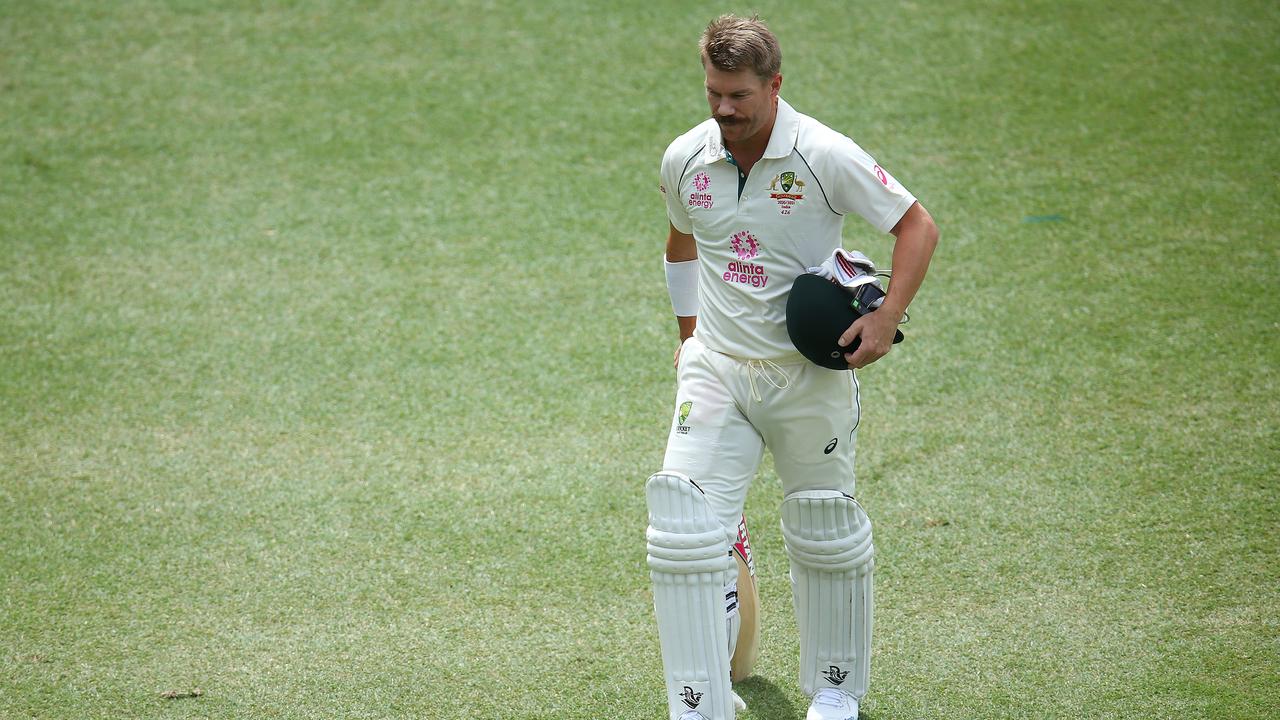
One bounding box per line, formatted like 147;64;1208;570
782;491;876;700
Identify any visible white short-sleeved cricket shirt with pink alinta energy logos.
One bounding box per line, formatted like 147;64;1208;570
659;97;915;360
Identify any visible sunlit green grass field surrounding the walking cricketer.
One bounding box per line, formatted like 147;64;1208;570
0;0;1280;720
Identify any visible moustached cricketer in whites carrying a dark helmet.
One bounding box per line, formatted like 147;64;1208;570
646;15;938;720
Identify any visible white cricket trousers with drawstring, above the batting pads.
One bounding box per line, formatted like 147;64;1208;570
662;336;860;528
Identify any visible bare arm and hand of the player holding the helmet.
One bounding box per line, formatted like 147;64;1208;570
840;202;938;368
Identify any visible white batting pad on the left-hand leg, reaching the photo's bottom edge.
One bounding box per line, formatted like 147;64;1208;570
645;471;737;720
